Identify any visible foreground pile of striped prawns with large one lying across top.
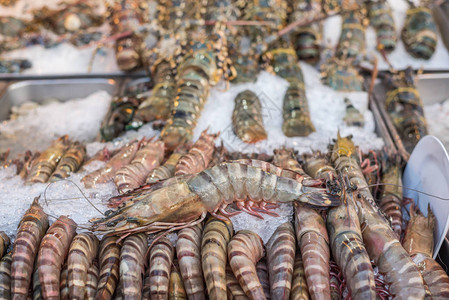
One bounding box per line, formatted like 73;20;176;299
0;132;449;299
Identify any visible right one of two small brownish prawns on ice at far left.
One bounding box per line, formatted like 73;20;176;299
49;142;86;182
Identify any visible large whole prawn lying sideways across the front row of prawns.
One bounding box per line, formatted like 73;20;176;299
91;160;340;237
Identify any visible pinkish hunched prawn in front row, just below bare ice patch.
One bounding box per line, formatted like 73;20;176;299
228;230;266;299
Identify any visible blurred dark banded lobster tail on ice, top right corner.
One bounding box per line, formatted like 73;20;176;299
401;6;438;59
